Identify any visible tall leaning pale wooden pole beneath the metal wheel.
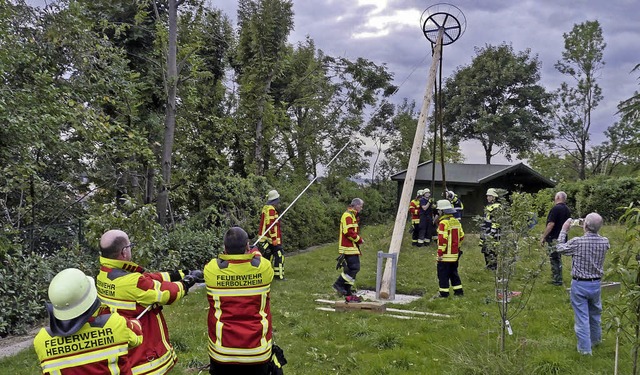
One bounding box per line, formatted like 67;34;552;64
380;28;444;299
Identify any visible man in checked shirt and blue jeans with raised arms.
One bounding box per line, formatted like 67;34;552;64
556;212;609;355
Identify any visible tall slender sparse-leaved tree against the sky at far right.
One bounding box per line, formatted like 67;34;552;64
554;21;606;180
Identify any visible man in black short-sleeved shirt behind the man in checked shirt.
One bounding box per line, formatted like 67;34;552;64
540;191;571;286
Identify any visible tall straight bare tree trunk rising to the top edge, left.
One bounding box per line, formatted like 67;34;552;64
157;0;178;225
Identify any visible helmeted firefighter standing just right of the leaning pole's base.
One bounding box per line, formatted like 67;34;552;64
437;199;464;298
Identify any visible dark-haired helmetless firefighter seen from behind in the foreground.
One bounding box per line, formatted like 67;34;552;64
204;227;286;375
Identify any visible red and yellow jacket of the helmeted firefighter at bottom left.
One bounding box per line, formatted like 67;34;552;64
33;306;143;375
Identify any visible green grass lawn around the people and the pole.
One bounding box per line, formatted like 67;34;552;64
0;222;632;375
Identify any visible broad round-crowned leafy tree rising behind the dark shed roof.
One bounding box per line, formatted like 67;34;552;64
442;44;551;164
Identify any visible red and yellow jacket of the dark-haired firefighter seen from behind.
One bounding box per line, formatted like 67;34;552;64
204;252;273;364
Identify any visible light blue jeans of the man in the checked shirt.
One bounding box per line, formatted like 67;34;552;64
571;280;602;354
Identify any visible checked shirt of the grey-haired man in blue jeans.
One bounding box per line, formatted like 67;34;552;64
556;231;610;279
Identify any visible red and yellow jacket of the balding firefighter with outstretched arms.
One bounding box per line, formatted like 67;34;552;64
96;257;186;374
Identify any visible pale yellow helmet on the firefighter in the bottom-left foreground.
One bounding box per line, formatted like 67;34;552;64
49;268;98;320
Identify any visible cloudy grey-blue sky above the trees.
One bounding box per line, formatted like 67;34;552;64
30;0;640;163
